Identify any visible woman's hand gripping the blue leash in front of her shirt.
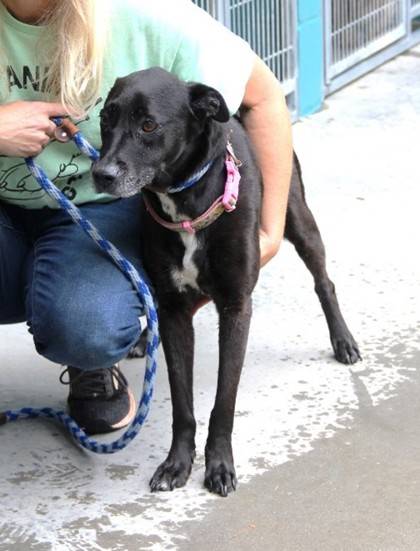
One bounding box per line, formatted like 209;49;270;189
0;101;66;157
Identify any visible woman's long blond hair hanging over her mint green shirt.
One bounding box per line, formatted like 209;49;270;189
0;0;108;116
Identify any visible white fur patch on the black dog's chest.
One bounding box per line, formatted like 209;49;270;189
158;193;200;292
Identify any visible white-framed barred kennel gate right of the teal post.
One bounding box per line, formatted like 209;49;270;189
324;0;420;89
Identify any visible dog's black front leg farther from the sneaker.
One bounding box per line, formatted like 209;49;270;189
204;297;252;497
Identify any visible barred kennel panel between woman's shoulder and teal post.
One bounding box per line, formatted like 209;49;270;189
195;0;297;95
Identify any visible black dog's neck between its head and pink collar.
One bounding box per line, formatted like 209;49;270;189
146;121;228;222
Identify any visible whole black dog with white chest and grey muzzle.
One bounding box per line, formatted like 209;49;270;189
93;68;360;496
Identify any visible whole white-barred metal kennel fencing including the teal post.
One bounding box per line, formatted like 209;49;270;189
193;0;420;116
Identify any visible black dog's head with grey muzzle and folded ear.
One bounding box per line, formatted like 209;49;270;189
92;68;229;197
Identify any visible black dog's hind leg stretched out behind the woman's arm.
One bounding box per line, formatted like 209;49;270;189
285;155;361;364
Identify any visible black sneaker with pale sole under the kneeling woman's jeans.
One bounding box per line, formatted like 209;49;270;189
60;365;136;434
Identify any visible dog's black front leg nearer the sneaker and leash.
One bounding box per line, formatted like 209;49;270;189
150;305;196;491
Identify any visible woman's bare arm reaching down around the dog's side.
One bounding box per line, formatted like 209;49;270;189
241;57;293;266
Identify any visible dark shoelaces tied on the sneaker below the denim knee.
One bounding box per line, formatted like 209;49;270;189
60;365;128;398
